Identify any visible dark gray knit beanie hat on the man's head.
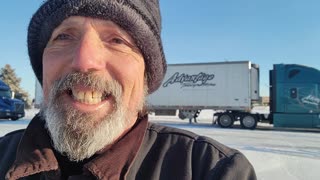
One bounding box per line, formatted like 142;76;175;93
28;0;167;94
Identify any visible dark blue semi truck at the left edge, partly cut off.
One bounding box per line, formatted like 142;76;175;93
0;80;25;120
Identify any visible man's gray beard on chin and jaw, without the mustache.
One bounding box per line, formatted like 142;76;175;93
44;101;129;161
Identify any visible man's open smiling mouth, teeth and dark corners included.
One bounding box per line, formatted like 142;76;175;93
67;89;111;105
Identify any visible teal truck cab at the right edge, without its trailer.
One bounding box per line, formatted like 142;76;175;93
270;64;320;128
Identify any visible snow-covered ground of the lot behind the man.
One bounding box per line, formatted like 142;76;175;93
0;108;320;180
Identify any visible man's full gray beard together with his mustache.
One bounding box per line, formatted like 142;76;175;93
41;72;147;161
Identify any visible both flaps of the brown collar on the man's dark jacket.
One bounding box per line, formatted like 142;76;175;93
6;115;148;179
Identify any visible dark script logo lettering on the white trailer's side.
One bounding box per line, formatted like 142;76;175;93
163;72;215;88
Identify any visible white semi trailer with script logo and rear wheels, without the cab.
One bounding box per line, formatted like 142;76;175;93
147;61;261;129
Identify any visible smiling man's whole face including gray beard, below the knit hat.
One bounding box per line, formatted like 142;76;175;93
43;16;146;160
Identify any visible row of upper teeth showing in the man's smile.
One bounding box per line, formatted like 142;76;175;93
72;90;102;104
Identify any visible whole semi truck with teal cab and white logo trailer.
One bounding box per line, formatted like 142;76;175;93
147;61;320;129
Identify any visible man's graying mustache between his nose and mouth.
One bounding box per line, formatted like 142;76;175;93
50;72;122;102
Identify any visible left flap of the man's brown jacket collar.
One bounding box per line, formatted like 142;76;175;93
6;115;58;179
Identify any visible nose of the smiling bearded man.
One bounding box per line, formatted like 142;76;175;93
72;32;104;72
